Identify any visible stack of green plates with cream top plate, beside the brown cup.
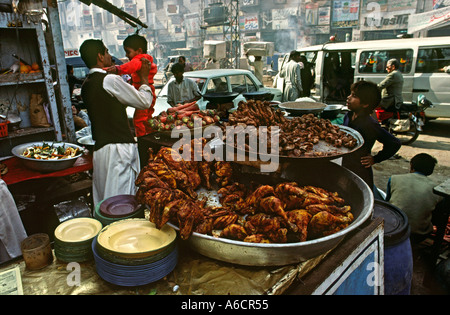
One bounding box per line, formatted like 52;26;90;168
54;218;102;262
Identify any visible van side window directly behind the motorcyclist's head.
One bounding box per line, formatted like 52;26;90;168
359;49;413;73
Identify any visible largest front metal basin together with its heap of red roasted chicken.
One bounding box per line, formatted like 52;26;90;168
136;144;373;266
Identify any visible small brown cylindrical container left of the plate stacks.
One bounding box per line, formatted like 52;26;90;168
20;233;53;270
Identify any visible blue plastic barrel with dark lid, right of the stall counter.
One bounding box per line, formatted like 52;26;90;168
373;200;413;295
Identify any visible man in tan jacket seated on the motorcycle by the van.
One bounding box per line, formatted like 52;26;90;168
378;59;403;109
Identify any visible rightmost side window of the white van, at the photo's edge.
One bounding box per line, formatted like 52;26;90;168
416;47;450;73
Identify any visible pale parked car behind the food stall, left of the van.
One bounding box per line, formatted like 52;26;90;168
127;69;282;117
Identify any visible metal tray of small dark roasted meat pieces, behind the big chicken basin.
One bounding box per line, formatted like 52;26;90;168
222;101;364;160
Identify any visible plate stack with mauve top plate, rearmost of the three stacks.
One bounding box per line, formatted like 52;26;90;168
94;195;145;226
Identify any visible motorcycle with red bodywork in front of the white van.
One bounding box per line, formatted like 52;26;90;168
375;94;433;145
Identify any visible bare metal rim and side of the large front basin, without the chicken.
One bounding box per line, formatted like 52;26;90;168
170;161;374;266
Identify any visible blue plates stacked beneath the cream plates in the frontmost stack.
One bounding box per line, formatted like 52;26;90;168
92;239;178;287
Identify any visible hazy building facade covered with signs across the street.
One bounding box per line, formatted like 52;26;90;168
58;0;450;66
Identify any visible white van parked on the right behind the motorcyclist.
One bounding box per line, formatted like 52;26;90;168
292;36;450;118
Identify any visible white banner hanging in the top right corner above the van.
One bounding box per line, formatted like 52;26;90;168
408;6;450;34
